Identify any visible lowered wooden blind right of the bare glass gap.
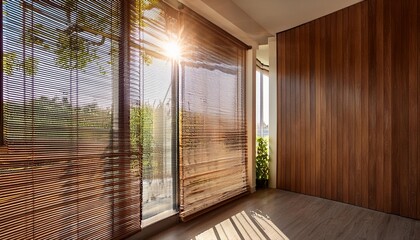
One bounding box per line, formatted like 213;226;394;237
180;8;247;219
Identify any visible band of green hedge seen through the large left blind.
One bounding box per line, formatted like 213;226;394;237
4;97;111;141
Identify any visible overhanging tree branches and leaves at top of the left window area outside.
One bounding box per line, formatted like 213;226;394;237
2;0;160;76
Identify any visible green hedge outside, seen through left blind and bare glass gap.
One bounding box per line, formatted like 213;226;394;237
4;94;158;179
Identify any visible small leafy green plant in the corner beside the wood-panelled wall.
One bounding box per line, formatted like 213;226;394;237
256;137;270;188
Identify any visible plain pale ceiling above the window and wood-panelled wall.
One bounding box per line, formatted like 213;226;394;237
180;0;362;45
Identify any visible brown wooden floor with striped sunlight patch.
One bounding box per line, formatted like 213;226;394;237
151;189;420;240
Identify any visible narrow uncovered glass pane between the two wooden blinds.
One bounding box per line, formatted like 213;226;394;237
134;5;178;225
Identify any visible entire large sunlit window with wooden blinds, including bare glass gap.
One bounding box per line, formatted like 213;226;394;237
0;0;247;239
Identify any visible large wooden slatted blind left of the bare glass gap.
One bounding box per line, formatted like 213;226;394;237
0;0;172;239
